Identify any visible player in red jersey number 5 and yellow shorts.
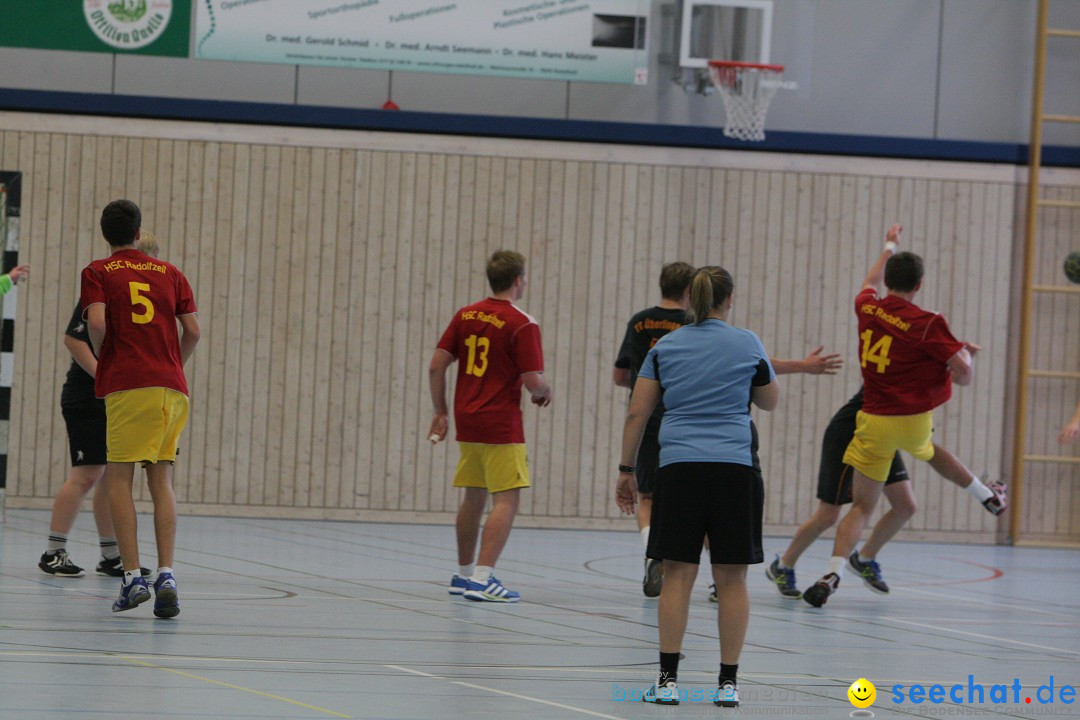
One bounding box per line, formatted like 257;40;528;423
82;200;199;617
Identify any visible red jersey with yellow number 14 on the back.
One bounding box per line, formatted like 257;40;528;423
855;288;963;415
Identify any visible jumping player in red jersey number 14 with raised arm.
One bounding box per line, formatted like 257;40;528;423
802;225;1005;608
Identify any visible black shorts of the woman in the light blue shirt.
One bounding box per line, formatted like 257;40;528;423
646;462;765;565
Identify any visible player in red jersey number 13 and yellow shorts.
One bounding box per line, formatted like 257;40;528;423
428;250;551;602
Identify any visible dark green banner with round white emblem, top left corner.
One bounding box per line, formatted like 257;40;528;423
0;0;191;57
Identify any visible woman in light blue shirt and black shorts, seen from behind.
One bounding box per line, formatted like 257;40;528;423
616;267;780;707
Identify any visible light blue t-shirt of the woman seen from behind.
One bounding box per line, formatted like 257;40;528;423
638;318;777;467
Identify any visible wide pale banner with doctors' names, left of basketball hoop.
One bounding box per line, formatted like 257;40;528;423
194;0;650;84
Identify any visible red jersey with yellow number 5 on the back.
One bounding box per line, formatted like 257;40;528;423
82;249;195;397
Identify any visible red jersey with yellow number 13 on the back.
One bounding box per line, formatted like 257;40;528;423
438;298;543;445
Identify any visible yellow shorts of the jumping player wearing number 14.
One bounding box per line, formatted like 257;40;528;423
843;410;934;483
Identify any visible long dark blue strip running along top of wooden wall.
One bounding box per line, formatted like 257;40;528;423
0;89;1080;167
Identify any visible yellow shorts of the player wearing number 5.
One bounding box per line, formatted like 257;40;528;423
105;388;188;464
